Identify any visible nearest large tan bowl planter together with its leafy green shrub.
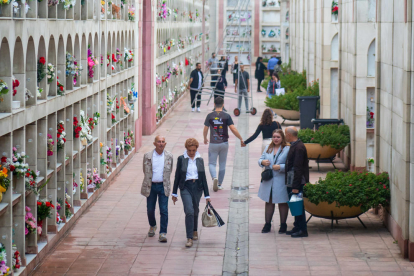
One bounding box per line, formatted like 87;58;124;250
303;171;391;219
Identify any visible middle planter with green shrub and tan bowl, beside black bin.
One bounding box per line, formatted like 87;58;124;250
298;125;350;159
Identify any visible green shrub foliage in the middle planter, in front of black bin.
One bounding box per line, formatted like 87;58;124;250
298;125;350;149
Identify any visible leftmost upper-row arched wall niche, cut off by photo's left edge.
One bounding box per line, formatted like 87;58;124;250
0;38;13;113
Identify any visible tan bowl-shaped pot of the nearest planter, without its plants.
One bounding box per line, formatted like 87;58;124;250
303;197;363;219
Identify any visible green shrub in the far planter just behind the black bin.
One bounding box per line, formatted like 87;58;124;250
265;79;319;111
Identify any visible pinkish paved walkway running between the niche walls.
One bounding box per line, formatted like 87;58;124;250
30;72;414;276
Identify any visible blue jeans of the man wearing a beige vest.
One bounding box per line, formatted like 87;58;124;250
147;183;168;234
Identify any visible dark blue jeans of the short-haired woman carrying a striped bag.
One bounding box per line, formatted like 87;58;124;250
180;180;203;239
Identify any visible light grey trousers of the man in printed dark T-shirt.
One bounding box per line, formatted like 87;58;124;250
208;142;229;185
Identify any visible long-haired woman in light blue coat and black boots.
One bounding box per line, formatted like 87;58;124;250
258;129;289;234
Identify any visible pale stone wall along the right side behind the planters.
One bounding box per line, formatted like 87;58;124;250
290;0;414;261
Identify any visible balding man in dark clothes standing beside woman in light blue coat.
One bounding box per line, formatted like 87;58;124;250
285;127;309;238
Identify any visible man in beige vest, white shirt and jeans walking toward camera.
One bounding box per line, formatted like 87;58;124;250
141;136;173;242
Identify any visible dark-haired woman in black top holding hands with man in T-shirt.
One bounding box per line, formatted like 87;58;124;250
243;108;282;152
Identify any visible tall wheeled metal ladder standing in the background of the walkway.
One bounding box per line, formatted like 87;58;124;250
190;0;257;116
